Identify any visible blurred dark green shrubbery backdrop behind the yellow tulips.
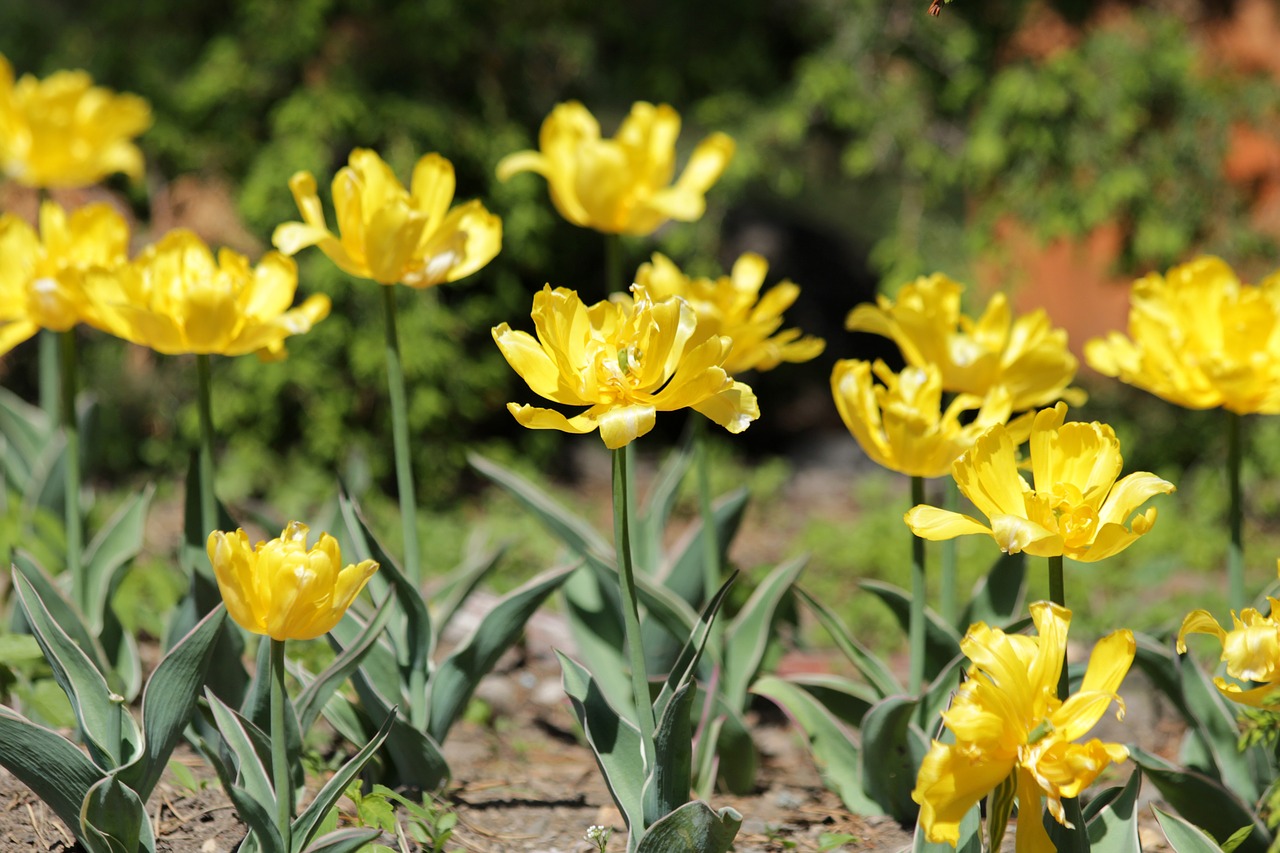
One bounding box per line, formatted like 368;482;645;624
0;0;1276;514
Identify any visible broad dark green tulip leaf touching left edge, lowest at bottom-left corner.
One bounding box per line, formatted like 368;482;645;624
0;706;104;829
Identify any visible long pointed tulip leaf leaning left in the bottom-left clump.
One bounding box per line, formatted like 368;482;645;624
13;571;138;771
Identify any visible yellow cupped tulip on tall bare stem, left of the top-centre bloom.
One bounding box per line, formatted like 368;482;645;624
271;149;502;288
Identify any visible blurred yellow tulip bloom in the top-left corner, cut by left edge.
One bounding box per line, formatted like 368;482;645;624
0;55;151;187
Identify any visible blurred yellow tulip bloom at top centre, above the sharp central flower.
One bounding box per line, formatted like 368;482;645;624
498;101;733;236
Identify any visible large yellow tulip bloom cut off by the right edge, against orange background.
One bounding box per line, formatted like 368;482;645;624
1084;256;1280;415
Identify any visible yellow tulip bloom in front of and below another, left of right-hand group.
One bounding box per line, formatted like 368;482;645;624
831;359;1030;476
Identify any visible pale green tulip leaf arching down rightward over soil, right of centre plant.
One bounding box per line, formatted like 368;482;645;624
751;675;884;816
